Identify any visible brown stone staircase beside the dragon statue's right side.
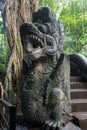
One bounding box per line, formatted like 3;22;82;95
70;77;87;130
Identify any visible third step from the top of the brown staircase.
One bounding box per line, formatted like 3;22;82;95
70;89;87;99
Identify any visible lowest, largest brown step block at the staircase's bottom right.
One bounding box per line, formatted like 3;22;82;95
73;111;87;130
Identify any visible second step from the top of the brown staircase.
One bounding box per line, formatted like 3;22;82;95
70;82;87;89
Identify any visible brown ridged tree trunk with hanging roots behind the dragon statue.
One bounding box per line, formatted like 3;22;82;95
1;0;38;109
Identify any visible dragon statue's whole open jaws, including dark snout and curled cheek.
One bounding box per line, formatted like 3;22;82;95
20;23;57;60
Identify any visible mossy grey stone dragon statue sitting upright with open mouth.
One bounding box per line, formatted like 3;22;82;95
20;7;70;130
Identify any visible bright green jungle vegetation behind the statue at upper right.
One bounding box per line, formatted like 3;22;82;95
40;0;87;56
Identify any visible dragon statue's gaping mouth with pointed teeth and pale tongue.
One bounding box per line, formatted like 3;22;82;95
26;35;45;60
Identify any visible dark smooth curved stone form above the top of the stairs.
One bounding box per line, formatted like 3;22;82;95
69;53;87;79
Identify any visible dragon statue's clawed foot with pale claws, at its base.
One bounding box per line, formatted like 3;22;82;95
42;120;61;130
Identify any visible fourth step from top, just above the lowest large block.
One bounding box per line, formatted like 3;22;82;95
71;98;87;112
